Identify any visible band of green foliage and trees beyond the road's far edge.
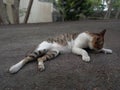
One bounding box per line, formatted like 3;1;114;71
55;0;120;21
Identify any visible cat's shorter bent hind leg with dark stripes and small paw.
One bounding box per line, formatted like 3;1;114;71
37;50;59;71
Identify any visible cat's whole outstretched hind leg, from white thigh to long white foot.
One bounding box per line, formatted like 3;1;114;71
9;41;52;73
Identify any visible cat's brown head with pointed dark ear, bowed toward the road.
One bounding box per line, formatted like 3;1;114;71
91;29;106;51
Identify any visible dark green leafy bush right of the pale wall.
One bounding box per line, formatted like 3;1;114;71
56;0;94;21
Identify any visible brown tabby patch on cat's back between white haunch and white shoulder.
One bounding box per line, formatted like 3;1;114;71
47;33;79;46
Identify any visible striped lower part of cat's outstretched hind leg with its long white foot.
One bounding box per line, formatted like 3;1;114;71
9;49;47;73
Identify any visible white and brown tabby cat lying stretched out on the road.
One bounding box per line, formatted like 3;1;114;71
9;29;112;73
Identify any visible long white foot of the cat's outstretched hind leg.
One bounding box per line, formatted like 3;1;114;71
9;60;24;73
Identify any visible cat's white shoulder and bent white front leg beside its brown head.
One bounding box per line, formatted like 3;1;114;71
72;33;92;62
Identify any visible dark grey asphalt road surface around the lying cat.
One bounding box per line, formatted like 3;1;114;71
0;20;120;90
